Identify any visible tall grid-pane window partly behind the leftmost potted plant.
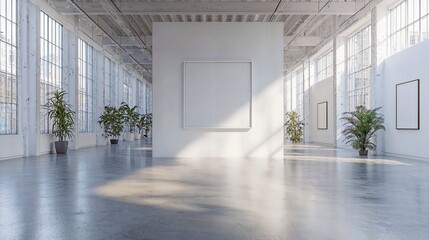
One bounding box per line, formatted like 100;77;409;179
40;12;63;133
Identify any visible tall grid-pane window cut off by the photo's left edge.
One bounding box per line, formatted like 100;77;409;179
0;0;18;135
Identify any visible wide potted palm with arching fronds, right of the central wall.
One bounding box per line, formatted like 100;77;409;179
341;106;386;156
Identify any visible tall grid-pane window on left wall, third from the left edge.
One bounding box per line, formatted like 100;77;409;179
78;38;95;133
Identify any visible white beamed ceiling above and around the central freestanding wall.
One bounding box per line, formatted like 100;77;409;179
49;0;371;81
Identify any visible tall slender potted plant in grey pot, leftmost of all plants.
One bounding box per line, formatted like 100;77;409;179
44;90;76;154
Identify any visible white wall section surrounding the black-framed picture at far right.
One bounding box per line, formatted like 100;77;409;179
380;41;429;159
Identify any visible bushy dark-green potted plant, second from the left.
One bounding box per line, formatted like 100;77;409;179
98;106;124;144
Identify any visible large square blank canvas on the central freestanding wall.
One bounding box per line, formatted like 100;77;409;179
183;61;252;130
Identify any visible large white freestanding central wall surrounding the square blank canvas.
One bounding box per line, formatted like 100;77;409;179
153;23;283;157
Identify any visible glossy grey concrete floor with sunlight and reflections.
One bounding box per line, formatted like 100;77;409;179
0;140;429;240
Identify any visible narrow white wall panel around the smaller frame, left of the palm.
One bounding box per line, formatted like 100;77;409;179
310;77;334;144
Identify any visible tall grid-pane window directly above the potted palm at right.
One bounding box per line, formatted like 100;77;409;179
348;26;371;110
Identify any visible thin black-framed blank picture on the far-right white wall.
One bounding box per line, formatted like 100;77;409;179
396;79;420;130
